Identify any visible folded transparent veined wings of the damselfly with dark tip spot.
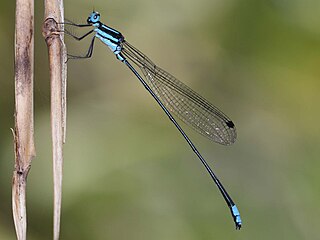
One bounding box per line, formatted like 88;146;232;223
122;41;237;145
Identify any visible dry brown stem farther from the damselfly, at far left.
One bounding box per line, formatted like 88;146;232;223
12;0;35;240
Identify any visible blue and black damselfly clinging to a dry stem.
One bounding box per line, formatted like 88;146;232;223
64;11;242;229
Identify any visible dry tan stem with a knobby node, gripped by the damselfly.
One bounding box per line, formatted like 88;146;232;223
42;0;66;240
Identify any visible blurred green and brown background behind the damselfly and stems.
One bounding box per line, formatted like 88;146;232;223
0;0;320;240
